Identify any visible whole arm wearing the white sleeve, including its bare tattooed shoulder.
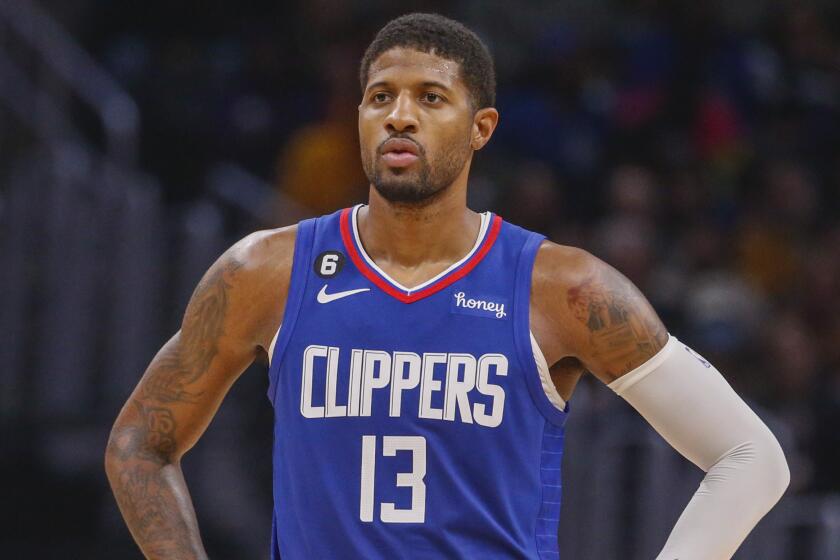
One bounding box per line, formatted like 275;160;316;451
534;243;790;560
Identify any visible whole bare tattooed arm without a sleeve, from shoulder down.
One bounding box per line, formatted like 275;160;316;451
105;227;296;560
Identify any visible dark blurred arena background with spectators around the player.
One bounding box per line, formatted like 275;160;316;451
0;0;840;560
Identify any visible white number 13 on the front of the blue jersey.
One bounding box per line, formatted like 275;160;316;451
359;436;426;523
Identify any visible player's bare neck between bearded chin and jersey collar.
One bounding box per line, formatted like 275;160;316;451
358;173;481;269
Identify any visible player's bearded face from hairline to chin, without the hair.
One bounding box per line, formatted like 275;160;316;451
359;48;480;205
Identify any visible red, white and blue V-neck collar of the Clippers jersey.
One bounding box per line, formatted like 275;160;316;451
339;204;502;303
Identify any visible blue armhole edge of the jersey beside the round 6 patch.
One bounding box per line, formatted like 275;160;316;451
268;218;315;404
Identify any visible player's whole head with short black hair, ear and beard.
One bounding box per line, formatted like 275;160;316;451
359;14;498;205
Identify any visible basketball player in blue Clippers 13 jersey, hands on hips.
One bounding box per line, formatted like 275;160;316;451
106;14;789;560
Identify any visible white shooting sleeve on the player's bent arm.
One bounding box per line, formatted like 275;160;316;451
608;336;790;560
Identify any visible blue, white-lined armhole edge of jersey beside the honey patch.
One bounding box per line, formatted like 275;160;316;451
513;233;570;426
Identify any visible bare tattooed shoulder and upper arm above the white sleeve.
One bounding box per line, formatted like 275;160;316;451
531;241;668;383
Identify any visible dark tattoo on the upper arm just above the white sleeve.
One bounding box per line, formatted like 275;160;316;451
566;269;668;379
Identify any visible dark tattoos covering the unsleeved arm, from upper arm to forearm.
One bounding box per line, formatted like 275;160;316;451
105;259;242;560
